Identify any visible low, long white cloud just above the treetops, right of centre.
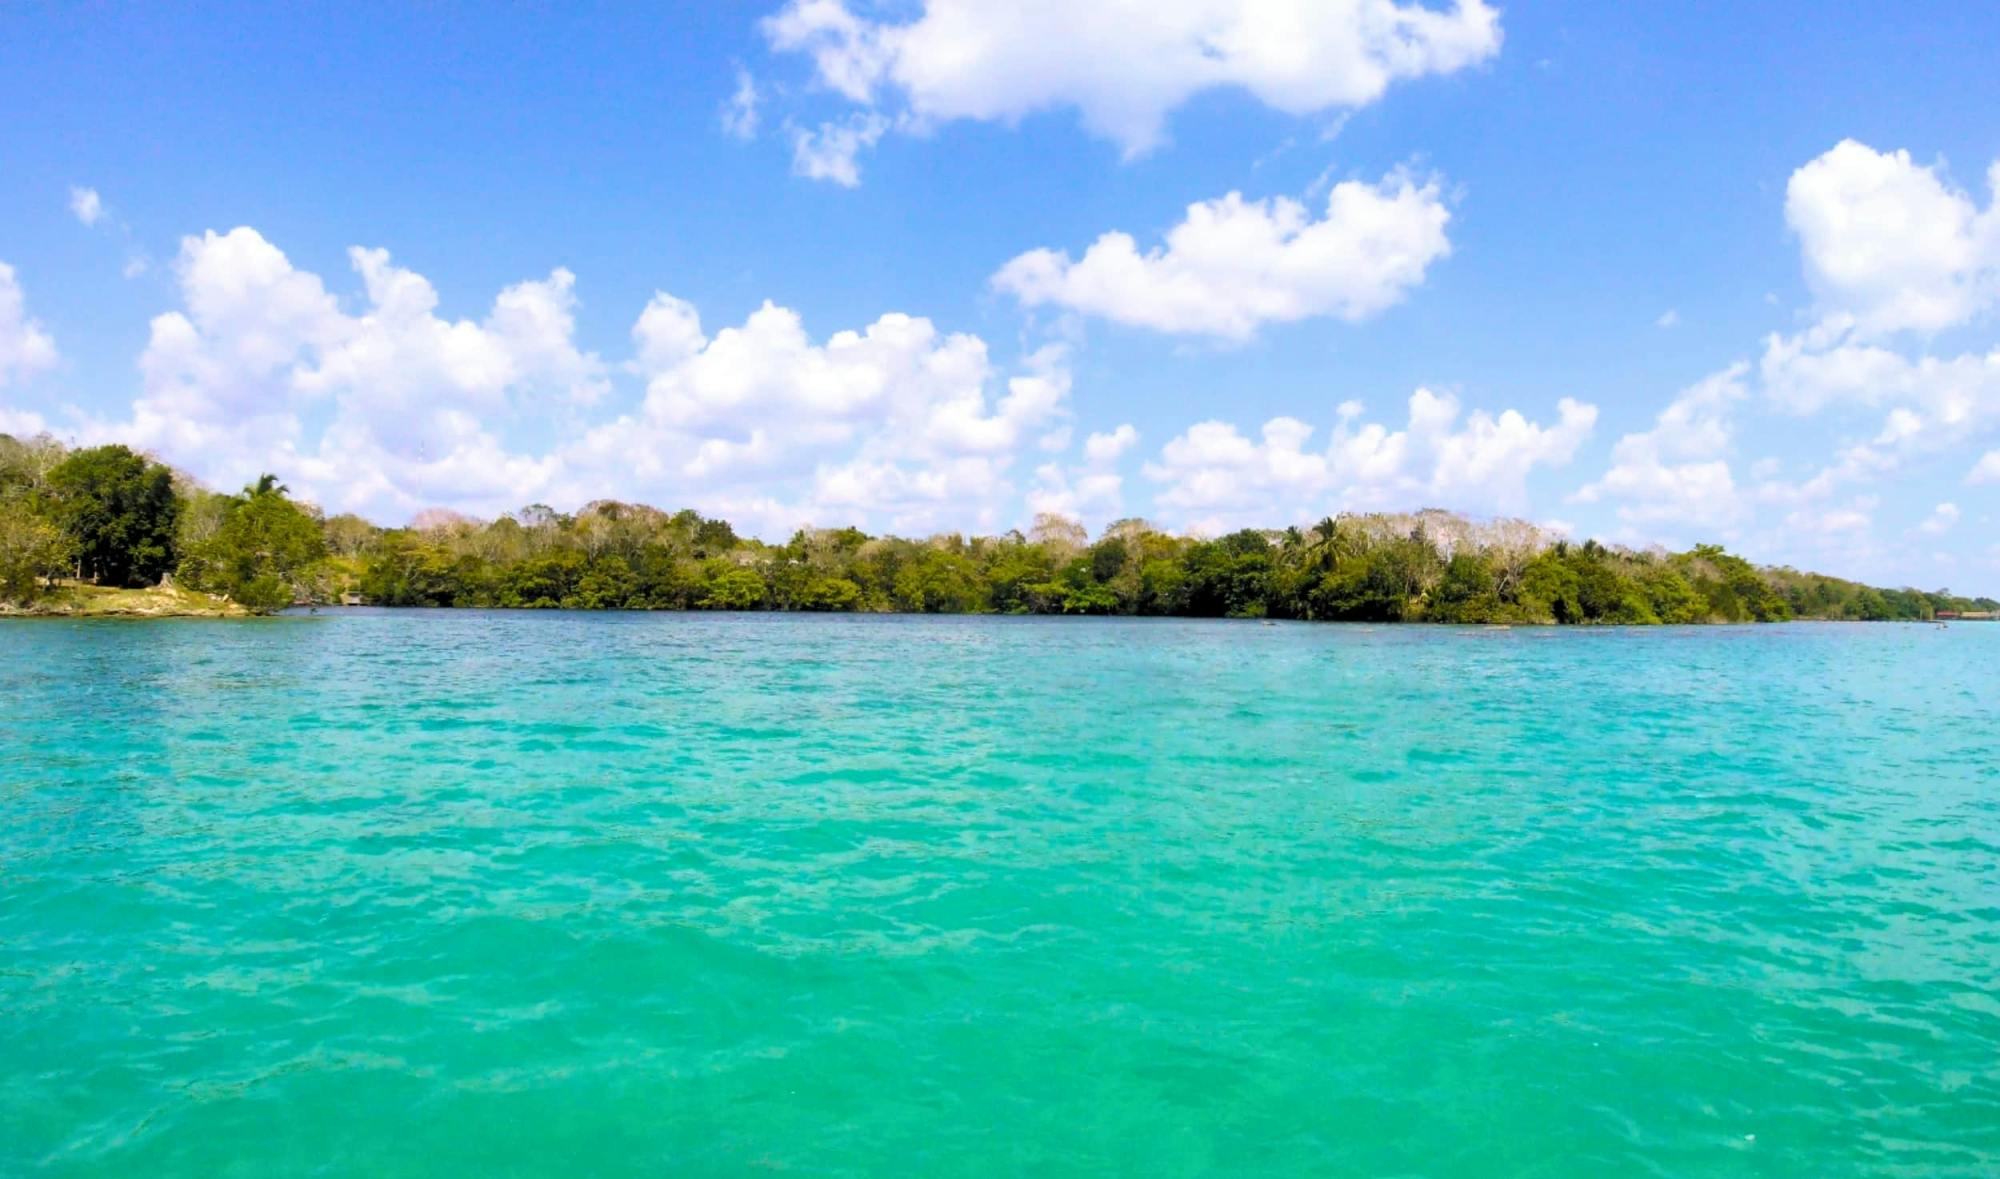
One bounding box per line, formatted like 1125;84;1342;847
1144;388;1598;528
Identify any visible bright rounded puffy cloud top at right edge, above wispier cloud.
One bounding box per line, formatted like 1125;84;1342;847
1784;140;2000;336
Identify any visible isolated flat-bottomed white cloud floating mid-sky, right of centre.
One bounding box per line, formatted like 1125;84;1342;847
992;174;1452;340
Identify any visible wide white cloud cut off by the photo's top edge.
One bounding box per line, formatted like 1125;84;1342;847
764;0;1500;170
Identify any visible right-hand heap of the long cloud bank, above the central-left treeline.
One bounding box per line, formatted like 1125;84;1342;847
562;294;1070;530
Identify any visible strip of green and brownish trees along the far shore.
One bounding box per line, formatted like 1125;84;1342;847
0;434;2000;623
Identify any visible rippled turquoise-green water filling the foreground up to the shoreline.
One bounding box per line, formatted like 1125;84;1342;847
0;611;2000;1177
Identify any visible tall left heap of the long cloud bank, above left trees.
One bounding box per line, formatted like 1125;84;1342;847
111;228;604;514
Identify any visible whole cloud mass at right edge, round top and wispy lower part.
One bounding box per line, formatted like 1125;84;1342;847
1574;140;2000;552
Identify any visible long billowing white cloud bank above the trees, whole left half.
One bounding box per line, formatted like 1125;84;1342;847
15;228;1080;534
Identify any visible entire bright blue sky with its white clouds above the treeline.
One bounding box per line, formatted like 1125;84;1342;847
0;0;2000;590
